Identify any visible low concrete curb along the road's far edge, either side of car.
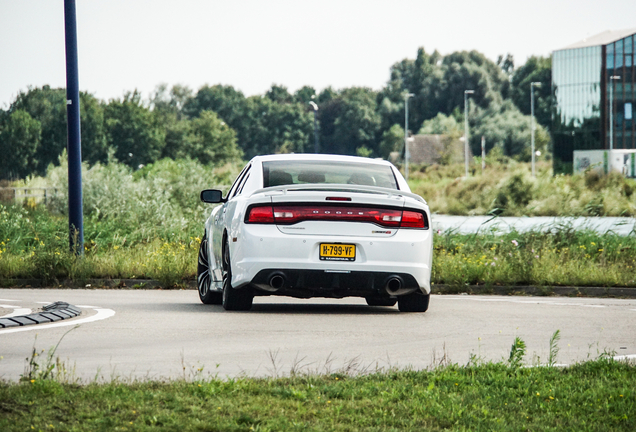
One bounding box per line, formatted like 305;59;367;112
0;279;636;298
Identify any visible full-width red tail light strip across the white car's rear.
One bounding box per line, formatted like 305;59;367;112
245;204;428;229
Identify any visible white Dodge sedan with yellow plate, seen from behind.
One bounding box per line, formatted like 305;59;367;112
197;154;433;312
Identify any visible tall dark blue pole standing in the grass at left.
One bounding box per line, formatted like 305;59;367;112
64;0;84;255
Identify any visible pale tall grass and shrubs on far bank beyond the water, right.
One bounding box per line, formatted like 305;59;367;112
409;160;636;216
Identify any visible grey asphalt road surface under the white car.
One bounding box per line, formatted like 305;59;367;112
0;289;636;380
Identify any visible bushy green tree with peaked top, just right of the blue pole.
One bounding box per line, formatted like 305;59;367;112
104;90;165;168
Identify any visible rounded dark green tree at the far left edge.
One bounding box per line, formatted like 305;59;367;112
0;110;42;180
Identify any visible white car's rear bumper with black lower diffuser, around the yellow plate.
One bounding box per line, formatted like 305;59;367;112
230;225;433;296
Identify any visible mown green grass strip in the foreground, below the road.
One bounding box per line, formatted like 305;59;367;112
0;357;636;431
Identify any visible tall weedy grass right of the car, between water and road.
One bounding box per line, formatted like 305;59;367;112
432;228;636;287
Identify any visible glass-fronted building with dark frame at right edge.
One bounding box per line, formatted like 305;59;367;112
552;28;636;173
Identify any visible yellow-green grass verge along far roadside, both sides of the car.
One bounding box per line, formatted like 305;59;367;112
0;205;636;289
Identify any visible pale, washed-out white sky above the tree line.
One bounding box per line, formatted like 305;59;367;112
0;0;636;109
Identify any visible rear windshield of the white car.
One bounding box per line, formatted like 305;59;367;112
263;161;398;189
